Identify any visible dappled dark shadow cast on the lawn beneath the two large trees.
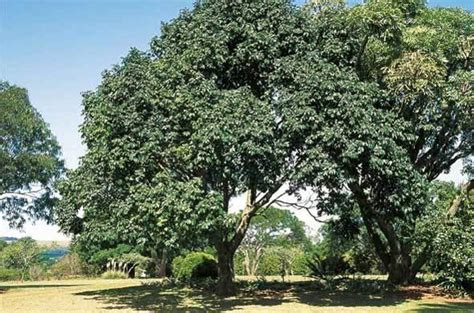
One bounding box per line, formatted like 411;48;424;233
76;282;428;312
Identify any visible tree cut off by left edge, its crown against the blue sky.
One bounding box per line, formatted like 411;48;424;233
0;82;63;227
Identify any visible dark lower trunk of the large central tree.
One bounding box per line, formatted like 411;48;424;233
217;244;235;296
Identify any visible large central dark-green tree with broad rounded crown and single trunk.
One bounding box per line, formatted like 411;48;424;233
58;0;318;293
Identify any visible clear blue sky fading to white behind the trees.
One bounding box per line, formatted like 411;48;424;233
0;0;474;240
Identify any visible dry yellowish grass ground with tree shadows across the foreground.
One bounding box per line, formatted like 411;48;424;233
0;277;474;313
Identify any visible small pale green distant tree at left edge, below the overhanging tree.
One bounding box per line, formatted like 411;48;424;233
0;237;45;281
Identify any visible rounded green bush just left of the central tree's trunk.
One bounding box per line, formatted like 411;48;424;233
172;252;217;280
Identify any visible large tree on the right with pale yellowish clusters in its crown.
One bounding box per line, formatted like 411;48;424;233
289;0;474;283
